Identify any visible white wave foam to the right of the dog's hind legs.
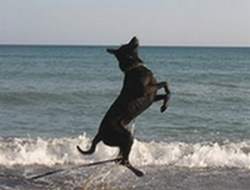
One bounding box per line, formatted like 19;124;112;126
131;141;250;169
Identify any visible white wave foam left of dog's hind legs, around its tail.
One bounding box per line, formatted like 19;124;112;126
0;135;116;166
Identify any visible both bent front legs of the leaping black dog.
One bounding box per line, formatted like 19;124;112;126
154;82;170;112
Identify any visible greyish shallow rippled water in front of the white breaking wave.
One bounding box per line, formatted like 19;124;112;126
0;167;250;190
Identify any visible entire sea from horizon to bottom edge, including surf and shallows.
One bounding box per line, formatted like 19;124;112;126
0;45;250;190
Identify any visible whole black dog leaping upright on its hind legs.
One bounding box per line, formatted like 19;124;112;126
77;37;170;176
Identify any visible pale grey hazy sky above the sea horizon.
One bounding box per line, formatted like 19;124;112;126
0;0;250;46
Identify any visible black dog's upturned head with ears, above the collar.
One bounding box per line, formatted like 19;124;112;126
107;37;142;72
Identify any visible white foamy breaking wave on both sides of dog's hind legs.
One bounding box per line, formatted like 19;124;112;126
0;134;250;169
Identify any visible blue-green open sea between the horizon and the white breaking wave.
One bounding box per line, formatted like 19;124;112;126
0;46;250;140
